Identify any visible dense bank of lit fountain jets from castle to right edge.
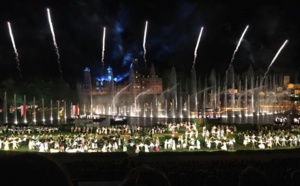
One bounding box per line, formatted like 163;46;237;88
87;66;291;118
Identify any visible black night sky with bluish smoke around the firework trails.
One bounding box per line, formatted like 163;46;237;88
0;0;300;86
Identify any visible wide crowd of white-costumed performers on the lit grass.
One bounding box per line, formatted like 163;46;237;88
0;122;300;153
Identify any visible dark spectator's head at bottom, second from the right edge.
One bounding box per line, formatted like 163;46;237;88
239;166;269;186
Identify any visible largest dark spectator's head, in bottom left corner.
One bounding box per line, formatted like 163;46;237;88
0;153;73;186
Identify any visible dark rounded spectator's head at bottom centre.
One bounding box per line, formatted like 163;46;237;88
120;166;171;186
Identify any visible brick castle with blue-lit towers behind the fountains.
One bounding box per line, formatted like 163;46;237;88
79;65;163;109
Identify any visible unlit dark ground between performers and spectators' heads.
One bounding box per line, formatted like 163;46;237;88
1;149;300;185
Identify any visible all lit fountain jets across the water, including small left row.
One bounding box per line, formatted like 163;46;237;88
3;63;289;124
